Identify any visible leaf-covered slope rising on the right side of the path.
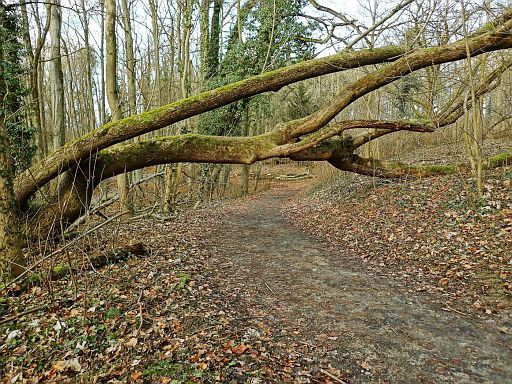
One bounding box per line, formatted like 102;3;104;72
286;168;512;319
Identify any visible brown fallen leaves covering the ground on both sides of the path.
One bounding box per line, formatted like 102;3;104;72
0;164;512;383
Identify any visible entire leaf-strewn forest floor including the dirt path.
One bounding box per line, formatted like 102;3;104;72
0;164;512;383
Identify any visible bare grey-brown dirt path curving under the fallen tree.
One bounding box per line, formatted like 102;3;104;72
202;188;512;383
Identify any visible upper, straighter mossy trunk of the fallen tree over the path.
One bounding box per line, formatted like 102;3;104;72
15;47;404;207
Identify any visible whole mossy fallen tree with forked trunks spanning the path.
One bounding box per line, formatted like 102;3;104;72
1;9;512;278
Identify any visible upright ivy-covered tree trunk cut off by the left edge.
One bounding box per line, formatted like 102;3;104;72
0;0;23;280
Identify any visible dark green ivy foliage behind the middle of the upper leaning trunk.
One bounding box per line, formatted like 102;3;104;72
199;0;316;136
